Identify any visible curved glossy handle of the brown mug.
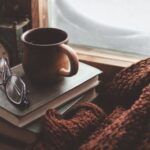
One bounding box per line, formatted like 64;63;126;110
58;44;79;77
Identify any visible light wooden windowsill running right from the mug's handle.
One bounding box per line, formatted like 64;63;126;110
71;44;146;67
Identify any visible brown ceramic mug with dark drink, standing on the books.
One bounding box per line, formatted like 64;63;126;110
21;28;79;83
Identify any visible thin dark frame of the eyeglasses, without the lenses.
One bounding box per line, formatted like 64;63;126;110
0;58;30;108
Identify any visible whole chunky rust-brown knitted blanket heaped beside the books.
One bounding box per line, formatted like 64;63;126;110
32;58;150;150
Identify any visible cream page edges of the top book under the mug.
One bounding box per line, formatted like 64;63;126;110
1;75;99;127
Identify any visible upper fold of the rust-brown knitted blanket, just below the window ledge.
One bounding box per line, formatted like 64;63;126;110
100;58;150;108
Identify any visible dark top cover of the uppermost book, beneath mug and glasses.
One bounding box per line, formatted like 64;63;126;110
4;62;102;118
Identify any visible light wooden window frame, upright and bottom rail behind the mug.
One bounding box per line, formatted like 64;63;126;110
31;0;145;67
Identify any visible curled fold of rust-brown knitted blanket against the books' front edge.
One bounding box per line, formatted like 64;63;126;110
38;103;106;150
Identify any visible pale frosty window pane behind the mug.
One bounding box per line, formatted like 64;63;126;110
49;0;150;55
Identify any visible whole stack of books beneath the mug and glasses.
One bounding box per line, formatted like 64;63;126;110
0;62;102;150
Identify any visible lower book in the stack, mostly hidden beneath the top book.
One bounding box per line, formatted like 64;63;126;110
0;88;97;145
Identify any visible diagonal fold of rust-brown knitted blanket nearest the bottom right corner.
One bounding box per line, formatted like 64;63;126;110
80;85;150;150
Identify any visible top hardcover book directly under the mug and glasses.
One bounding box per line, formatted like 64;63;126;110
0;63;101;127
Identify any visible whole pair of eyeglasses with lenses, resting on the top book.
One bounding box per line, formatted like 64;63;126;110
0;58;30;108
